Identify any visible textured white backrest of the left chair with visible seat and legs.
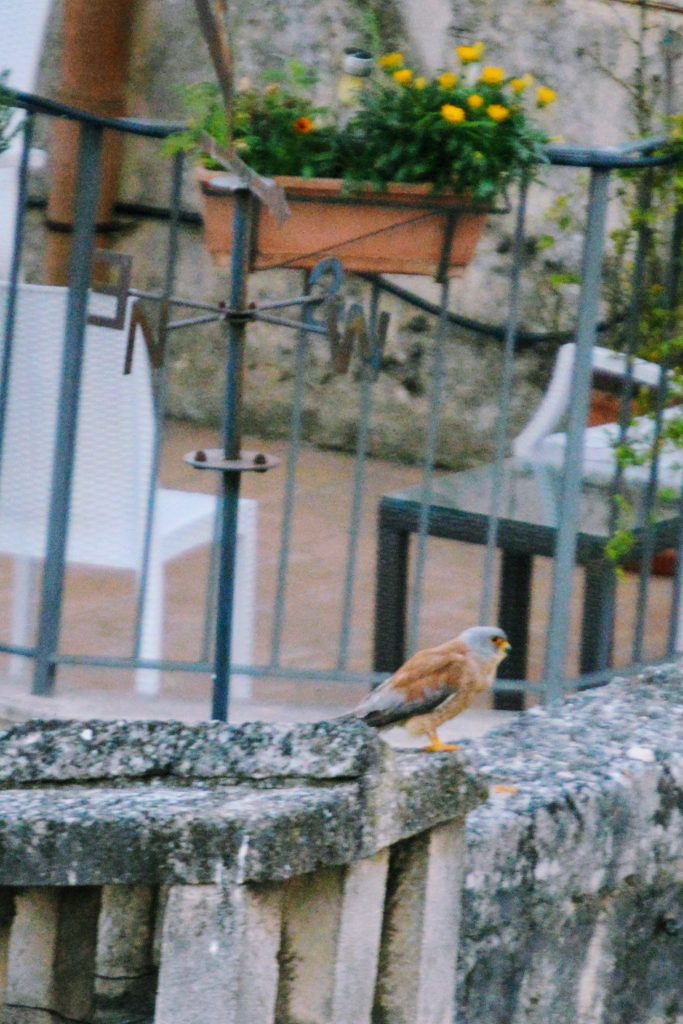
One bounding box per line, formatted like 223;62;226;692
0;285;155;568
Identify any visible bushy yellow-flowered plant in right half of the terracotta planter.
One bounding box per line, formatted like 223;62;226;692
345;44;555;202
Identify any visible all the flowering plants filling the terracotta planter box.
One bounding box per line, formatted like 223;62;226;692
167;44;554;203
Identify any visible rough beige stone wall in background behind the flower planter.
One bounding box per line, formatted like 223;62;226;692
25;0;678;468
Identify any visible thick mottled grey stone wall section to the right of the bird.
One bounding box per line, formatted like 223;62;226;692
450;665;683;1024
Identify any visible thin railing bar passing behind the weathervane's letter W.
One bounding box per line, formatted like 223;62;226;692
337;281;380;672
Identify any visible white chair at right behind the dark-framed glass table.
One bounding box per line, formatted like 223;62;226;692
512;343;683;487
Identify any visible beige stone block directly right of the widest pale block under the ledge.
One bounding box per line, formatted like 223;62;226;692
278;850;388;1024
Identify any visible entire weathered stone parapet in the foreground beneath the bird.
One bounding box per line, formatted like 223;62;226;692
0;667;683;1024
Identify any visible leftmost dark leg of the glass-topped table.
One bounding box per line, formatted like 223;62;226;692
373;520;409;672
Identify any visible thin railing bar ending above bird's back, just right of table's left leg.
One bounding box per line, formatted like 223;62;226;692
408;278;450;654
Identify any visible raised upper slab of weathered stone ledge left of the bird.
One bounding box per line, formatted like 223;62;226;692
0;720;386;788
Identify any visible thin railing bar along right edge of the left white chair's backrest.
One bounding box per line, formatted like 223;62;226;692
133;153;184;658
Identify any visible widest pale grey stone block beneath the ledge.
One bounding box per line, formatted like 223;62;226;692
155;885;282;1024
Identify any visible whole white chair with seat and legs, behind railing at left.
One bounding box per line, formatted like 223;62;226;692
0;284;257;695
